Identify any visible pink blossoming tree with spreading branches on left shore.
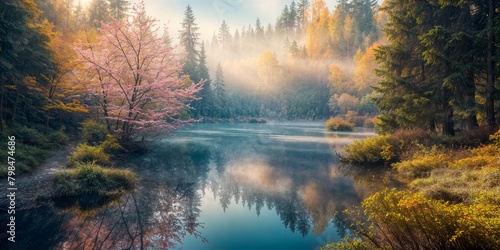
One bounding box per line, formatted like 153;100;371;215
75;4;202;140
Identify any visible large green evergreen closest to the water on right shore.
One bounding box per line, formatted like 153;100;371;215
374;0;438;131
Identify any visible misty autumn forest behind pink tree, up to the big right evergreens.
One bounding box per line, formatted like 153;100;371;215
0;0;384;137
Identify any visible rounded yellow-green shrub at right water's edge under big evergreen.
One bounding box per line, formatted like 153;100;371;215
342;135;396;164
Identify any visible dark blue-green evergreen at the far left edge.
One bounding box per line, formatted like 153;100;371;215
0;0;54;131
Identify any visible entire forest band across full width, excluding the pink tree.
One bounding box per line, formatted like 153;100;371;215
0;0;500;138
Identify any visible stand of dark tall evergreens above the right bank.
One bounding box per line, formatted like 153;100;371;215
374;0;500;135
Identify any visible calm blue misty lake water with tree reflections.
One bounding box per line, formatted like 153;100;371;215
7;122;373;249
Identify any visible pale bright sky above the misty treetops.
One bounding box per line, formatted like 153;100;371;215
145;0;336;42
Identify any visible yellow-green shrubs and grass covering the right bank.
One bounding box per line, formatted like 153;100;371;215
322;127;500;250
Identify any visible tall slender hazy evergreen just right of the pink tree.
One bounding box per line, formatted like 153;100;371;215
179;5;200;82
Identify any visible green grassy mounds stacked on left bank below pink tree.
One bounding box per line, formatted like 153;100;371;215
53;120;137;198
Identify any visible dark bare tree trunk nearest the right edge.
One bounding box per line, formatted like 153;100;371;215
486;0;495;126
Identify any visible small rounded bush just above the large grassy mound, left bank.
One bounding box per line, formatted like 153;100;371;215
67;143;111;167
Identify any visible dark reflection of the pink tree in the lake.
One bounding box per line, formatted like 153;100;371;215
51;142;211;249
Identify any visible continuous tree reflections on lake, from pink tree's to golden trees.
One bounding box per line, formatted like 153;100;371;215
54;130;368;249
